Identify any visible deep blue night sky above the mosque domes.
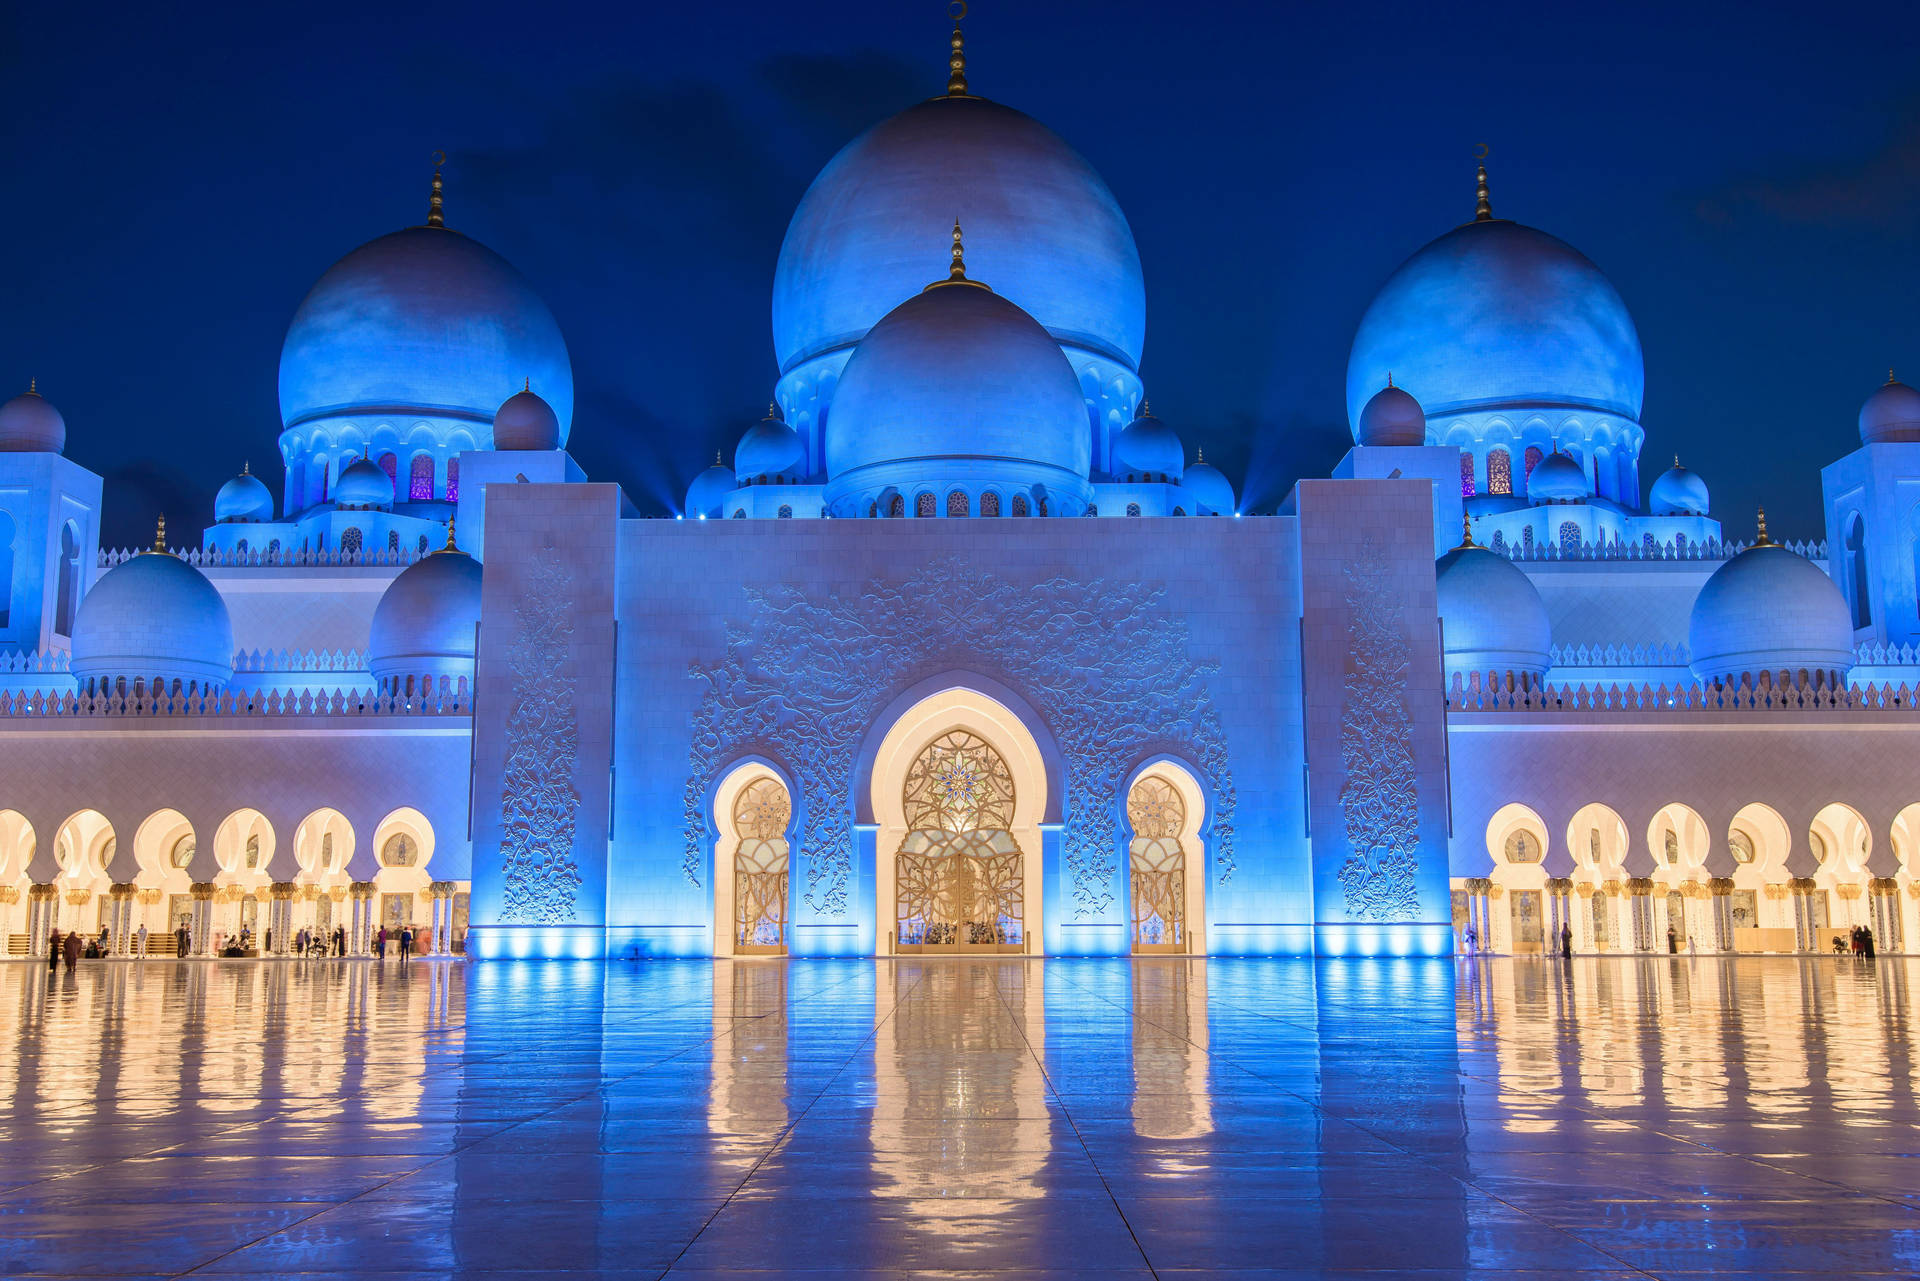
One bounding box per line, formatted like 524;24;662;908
0;0;1920;544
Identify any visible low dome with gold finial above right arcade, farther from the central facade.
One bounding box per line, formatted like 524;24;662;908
1688;509;1853;684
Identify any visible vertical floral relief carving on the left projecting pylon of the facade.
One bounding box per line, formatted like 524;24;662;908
499;549;580;926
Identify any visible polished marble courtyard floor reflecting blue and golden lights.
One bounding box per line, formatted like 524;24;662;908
0;956;1920;1281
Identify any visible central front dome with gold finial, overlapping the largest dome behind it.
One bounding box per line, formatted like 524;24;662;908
826;223;1092;515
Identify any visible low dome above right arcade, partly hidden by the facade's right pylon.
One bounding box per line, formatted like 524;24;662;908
1434;520;1553;676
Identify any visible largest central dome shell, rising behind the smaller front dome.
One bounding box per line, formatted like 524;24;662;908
774;98;1146;378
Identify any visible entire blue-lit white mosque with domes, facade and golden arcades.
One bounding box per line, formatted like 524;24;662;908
0;17;1920;956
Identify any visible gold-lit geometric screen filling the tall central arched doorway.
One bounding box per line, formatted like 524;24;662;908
893;730;1027;955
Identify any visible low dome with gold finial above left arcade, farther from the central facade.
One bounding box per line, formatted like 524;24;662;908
73;519;234;693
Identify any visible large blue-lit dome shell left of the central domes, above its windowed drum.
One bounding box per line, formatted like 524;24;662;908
280;227;574;444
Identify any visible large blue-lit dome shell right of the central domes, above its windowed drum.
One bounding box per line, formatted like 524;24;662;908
1346;219;1645;423
